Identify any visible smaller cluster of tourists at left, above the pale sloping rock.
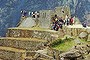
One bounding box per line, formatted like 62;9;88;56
21;10;39;18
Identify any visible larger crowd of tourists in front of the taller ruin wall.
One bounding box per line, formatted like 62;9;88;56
51;15;74;31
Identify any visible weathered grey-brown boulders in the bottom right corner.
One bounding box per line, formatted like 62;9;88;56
60;45;90;60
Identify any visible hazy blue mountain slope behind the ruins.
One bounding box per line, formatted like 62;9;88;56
0;0;90;36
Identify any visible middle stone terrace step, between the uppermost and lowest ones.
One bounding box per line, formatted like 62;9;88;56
0;37;47;51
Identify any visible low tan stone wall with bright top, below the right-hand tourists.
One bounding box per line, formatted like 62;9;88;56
63;26;90;37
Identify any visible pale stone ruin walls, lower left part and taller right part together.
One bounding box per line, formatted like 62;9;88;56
38;6;71;28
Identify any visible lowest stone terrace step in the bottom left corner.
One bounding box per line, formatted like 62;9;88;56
0;46;26;60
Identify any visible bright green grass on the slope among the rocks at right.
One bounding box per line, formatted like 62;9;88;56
52;38;90;52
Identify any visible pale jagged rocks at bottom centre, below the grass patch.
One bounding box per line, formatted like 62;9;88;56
25;47;60;60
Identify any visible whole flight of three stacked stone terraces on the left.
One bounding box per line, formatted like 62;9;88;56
0;27;58;60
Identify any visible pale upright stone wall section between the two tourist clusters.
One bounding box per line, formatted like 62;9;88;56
39;10;53;28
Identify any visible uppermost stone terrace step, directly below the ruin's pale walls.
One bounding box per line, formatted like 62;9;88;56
6;27;58;41
